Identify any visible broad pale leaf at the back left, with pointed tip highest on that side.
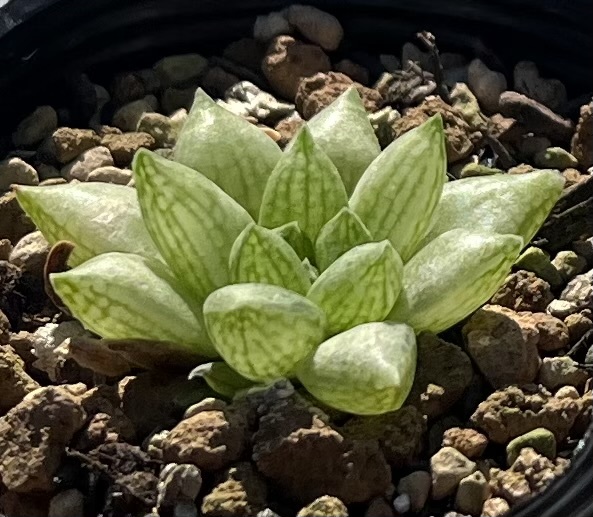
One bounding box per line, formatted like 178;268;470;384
174;88;282;218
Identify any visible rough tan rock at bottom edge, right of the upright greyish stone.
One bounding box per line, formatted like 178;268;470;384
201;462;266;517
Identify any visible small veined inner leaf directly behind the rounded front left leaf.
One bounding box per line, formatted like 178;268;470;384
229;224;311;295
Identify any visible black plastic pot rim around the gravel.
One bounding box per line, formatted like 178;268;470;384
0;0;593;517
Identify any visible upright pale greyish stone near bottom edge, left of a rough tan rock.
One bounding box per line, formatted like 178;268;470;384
157;463;202;511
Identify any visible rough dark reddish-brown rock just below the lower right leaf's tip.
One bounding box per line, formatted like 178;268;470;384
490;270;554;312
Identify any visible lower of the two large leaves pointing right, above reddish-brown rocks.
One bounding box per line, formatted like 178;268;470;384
389;229;523;333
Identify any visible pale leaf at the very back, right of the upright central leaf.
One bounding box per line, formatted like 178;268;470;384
308;87;381;195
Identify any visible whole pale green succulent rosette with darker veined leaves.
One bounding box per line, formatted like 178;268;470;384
17;89;564;414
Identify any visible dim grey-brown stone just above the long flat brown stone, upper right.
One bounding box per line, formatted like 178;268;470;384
513;61;567;110
